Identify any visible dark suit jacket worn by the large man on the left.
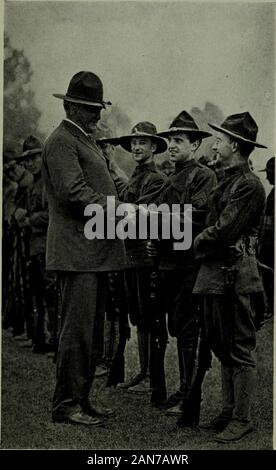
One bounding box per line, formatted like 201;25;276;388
43;121;125;272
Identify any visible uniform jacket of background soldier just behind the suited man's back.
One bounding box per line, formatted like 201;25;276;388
27;174;49;256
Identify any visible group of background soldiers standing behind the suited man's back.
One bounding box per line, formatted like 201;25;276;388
2;136;58;353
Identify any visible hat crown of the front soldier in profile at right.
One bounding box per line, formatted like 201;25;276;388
221;112;258;141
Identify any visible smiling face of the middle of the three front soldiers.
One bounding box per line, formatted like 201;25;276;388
168;132;197;163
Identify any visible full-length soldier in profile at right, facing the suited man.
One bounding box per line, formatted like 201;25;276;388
194;112;265;442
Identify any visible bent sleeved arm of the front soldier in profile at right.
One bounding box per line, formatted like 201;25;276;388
194;179;265;259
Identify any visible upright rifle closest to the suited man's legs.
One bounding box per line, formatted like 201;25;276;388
106;272;130;387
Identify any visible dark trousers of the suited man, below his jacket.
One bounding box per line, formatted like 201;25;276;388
53;272;105;417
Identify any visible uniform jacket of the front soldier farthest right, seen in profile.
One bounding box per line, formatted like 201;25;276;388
194;163;265;294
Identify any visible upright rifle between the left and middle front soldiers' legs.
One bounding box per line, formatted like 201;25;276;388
150;256;168;407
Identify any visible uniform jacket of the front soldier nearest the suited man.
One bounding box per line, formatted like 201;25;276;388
111;162;166;267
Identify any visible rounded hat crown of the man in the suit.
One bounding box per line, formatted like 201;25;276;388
66;71;103;103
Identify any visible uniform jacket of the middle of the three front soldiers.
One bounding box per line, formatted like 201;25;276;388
151;159;217;272
